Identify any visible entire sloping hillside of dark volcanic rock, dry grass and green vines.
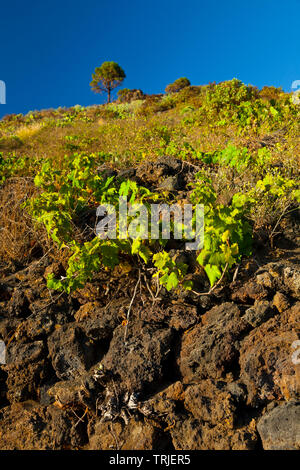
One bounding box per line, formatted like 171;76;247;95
0;79;300;450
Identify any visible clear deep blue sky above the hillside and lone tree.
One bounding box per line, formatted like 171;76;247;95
0;0;300;117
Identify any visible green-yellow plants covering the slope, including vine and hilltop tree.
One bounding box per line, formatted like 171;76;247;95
0;78;300;292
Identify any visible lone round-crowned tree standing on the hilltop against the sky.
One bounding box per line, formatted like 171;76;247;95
90;62;126;103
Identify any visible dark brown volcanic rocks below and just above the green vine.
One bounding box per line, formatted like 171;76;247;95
0;157;300;451
